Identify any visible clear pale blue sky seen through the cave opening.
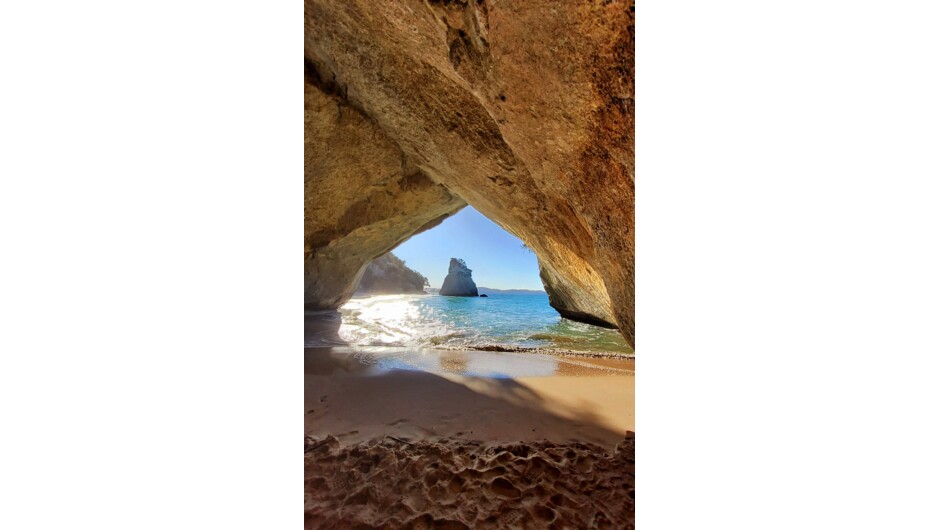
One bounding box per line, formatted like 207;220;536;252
392;206;543;291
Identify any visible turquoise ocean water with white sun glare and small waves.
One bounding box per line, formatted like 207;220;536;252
339;293;632;354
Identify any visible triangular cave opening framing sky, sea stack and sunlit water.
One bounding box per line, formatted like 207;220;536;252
324;206;632;354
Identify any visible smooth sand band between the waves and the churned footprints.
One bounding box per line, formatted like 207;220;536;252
304;348;634;448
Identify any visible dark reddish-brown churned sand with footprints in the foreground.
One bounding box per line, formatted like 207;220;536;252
304;432;634;529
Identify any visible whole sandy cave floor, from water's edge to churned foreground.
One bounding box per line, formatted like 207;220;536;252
304;347;634;528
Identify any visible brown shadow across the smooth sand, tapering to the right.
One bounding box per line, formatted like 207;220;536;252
304;348;624;449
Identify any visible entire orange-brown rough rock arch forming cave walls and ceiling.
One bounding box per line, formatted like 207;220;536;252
304;0;634;346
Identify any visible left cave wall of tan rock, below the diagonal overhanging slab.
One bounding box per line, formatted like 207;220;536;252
304;60;466;309
